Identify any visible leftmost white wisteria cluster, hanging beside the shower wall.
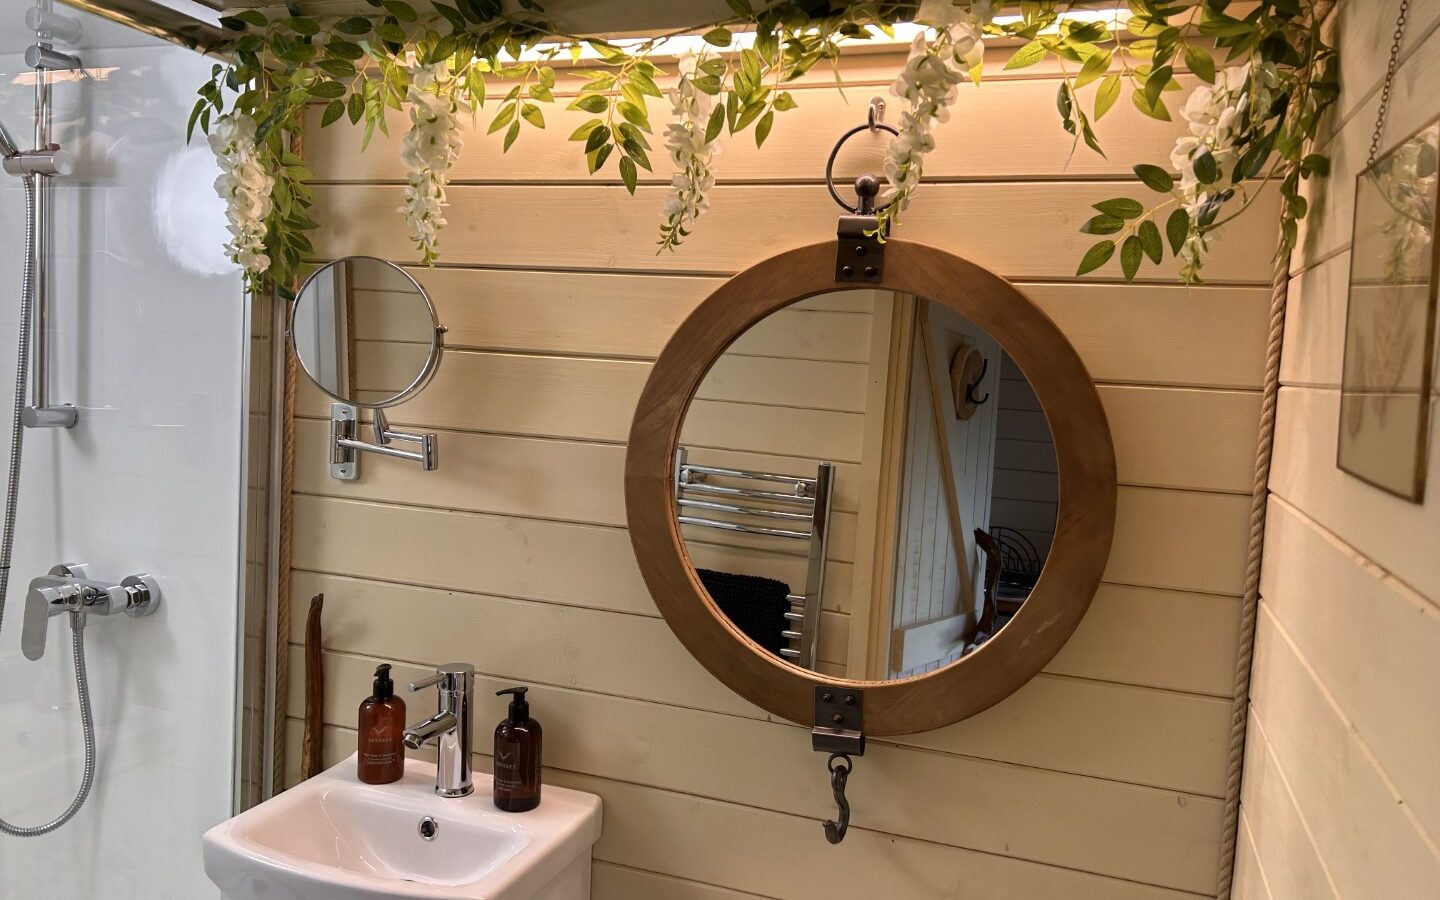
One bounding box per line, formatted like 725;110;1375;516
210;114;275;281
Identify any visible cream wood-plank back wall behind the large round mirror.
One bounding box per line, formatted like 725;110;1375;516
289;43;1276;900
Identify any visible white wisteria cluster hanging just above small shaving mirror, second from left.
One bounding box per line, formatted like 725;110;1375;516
399;60;464;265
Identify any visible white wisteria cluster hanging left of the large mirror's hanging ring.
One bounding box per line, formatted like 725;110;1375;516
660;55;720;251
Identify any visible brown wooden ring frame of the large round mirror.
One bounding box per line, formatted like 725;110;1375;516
625;239;1116;734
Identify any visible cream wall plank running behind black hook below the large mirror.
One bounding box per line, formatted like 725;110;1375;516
288;647;1220;890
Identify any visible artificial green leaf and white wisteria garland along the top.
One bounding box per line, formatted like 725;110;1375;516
187;0;1339;288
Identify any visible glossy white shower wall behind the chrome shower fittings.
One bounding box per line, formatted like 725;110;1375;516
0;0;246;900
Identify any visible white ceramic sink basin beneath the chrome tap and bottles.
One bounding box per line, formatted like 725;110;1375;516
204;756;600;900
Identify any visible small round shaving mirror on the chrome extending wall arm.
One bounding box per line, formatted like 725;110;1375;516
289;256;441;409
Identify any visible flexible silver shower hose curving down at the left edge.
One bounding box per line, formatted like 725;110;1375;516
0;176;95;838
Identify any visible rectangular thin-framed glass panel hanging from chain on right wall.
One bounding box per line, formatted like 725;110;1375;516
1338;113;1440;503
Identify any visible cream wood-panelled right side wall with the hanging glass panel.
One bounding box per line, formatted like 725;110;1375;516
1234;0;1440;900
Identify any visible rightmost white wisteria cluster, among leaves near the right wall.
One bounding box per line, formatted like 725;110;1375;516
1171;66;1251;284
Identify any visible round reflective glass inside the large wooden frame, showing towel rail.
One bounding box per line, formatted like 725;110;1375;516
675;289;1058;680
